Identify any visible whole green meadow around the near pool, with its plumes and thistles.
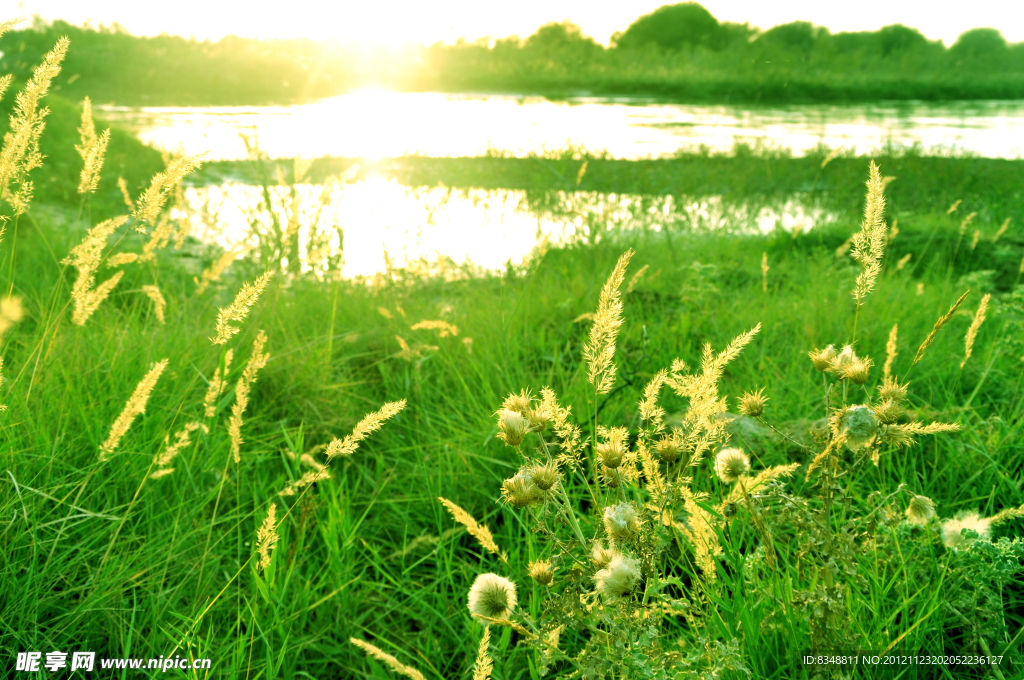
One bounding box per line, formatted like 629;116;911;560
0;23;1024;678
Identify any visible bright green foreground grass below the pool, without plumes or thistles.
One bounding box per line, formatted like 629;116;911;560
0;178;1024;678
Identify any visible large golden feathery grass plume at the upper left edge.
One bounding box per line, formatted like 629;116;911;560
0;34;71;215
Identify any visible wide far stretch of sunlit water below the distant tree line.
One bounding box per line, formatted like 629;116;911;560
100;92;1024;160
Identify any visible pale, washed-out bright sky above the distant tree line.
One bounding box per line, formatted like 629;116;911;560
8;0;1024;45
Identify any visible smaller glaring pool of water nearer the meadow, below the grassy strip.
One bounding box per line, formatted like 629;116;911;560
178;178;835;278
